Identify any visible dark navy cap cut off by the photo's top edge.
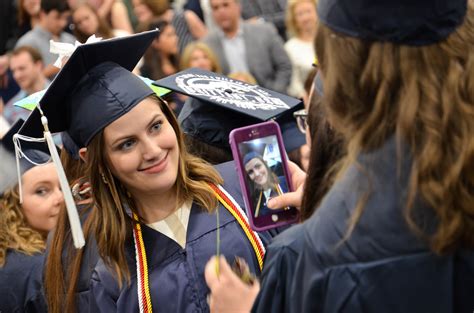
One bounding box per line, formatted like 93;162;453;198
318;0;467;46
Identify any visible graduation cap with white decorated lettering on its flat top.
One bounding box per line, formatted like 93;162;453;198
154;68;305;151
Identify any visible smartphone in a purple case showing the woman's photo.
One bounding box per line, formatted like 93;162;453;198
229;121;299;231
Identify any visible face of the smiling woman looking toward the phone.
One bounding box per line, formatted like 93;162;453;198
104;98;179;197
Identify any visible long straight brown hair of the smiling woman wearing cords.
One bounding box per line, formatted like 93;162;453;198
45;96;223;313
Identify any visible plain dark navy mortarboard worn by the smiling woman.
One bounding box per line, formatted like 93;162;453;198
20;30;158;147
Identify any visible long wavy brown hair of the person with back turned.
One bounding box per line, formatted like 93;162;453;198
316;8;474;254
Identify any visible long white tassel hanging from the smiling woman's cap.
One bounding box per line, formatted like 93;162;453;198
41;115;85;249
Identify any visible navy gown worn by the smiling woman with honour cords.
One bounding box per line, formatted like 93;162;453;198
91;162;271;313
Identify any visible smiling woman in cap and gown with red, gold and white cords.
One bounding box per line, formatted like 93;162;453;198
18;31;278;313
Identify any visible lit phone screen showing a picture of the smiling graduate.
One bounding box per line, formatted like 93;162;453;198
239;135;289;218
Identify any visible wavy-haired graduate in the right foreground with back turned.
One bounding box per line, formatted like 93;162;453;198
206;0;474;312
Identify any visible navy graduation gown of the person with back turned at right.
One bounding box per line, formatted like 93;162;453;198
262;138;474;313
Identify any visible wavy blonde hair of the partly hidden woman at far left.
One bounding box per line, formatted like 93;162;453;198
0;187;45;268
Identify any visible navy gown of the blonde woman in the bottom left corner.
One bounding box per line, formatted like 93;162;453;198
0;250;47;313
